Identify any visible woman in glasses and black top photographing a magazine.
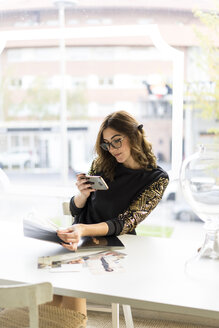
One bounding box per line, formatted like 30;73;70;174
58;111;168;251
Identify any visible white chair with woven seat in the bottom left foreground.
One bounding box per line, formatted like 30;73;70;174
0;282;87;328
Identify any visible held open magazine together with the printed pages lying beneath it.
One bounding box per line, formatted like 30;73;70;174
23;218;126;274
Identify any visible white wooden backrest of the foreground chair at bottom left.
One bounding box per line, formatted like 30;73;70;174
0;282;53;328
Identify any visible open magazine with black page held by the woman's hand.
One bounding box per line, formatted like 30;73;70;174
23;219;124;251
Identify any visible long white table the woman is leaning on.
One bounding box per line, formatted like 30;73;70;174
0;221;219;326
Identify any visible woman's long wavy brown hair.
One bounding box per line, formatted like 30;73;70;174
95;111;157;180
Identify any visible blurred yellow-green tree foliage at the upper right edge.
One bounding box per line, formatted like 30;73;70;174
188;0;219;119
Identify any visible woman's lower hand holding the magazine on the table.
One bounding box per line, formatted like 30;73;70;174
57;224;82;251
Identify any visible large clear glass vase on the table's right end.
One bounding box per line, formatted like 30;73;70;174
180;144;219;280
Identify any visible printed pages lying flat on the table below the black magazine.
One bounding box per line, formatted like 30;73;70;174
38;250;126;274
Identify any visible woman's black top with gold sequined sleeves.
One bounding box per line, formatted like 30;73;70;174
70;163;168;235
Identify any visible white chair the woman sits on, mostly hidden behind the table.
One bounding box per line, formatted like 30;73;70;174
62;202;134;328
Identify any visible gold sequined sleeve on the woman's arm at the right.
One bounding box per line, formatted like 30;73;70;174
118;177;169;235
